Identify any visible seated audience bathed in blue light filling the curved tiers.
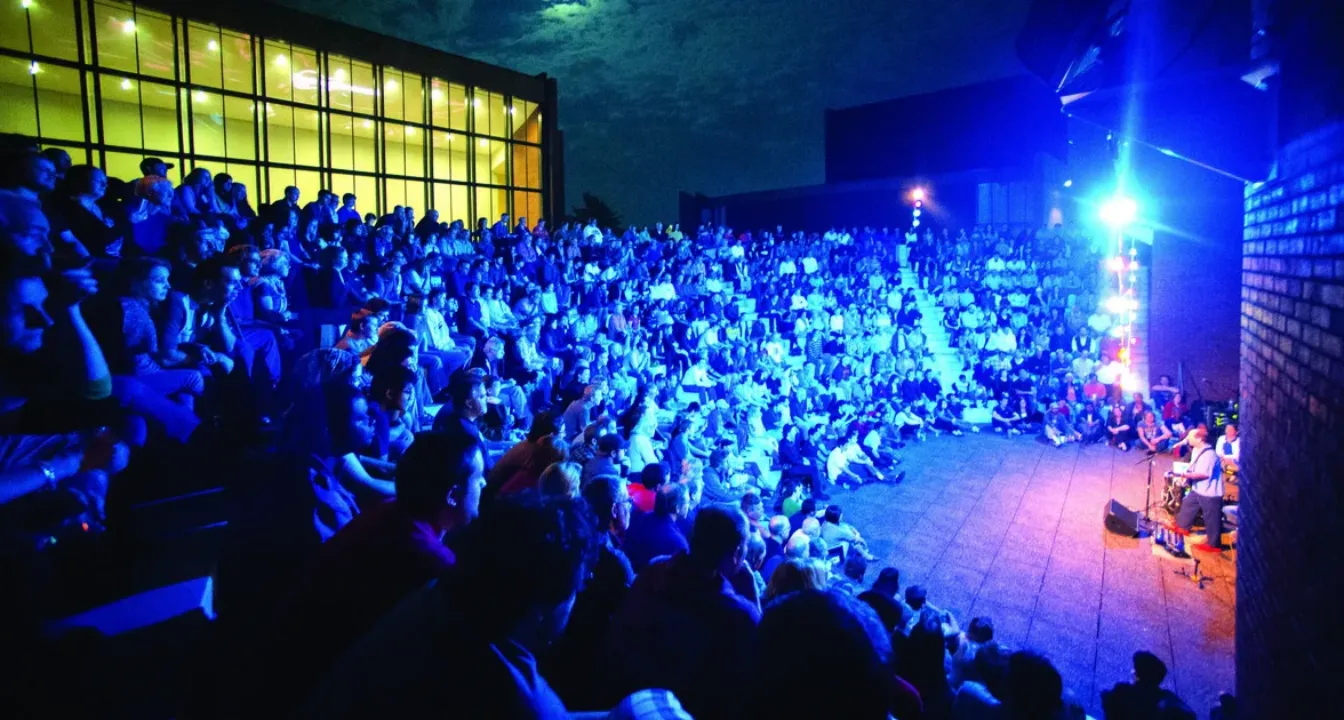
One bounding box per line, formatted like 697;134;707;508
0;138;1231;720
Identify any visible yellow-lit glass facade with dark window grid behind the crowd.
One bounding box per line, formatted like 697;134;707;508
0;0;547;224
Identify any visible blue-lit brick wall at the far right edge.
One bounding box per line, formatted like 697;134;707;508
1236;118;1344;717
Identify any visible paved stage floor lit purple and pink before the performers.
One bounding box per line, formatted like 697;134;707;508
831;433;1236;717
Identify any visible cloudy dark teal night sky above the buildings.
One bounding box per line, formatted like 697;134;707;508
272;0;1028;224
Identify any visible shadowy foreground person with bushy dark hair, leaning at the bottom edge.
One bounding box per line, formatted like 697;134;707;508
305;494;597;717
